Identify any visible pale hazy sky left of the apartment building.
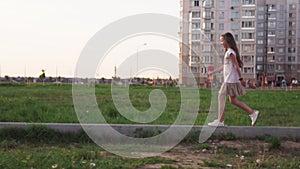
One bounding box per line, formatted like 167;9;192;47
0;0;180;77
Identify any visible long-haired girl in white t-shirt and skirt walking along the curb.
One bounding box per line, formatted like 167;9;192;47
208;33;259;126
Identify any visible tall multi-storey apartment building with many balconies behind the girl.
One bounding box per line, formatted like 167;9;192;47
179;0;300;85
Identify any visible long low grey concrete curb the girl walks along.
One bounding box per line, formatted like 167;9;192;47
0;122;300;139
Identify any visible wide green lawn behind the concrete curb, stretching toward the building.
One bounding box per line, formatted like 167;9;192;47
0;83;300;126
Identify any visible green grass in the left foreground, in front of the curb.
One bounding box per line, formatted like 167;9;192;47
0;126;174;169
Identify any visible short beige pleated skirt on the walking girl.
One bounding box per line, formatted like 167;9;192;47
219;83;246;96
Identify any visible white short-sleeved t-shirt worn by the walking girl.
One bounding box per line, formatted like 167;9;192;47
223;48;240;83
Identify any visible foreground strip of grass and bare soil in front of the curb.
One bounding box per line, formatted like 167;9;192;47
0;126;300;169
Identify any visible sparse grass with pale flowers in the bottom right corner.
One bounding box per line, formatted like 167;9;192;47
204;141;300;169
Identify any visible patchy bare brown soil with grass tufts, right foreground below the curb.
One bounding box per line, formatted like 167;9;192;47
139;140;300;169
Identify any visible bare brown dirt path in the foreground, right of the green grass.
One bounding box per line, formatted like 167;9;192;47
138;140;300;169
